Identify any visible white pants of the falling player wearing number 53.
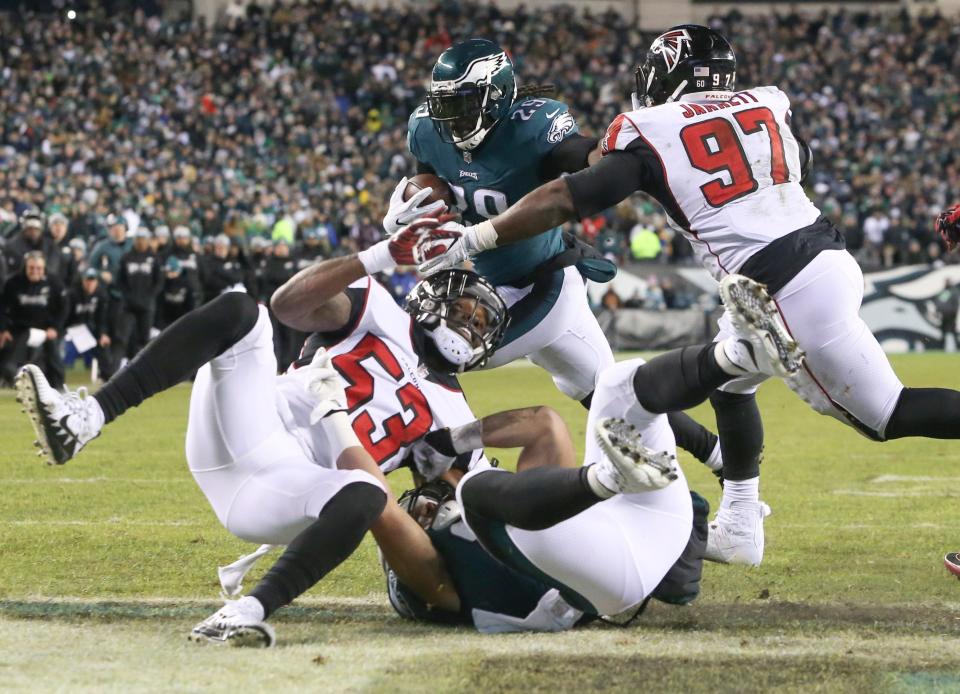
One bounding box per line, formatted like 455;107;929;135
186;306;383;545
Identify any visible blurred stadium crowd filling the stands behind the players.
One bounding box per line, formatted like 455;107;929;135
0;1;960;386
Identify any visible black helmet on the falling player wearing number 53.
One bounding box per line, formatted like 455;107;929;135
406;269;510;374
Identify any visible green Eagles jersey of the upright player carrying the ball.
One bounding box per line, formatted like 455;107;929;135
407;99;579;285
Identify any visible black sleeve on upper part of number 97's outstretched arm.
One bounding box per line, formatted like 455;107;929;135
563;150;650;219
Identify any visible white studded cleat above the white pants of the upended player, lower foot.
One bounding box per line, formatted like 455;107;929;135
595;417;677;494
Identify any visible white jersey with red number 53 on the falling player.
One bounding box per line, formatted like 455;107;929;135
278;277;483;473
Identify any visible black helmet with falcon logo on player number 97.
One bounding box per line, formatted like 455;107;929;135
633;24;737;108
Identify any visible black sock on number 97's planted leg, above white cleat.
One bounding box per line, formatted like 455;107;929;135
710;390;763;481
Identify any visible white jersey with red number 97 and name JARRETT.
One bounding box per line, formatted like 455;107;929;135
601;87;820;280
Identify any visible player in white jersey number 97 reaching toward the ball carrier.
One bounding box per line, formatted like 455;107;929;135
422;25;960;565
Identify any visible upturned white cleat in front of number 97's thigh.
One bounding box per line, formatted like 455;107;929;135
720;274;804;378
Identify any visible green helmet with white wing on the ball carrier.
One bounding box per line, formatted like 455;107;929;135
427;39;517;151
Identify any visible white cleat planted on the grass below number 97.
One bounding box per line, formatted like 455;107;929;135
703;501;770;566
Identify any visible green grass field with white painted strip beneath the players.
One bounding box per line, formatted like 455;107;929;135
0;354;960;692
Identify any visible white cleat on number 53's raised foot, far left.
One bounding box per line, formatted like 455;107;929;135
15;364;103;465
